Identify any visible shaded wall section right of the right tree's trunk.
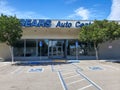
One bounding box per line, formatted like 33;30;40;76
99;40;120;59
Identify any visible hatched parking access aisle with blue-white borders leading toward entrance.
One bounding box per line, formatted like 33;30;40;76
52;64;102;90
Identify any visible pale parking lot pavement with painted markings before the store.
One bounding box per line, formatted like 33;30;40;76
0;60;120;90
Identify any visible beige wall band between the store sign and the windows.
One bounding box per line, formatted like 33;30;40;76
22;27;79;39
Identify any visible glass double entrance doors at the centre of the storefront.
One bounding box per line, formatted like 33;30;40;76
49;40;64;58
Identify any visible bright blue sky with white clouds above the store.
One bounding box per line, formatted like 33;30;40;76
0;0;120;20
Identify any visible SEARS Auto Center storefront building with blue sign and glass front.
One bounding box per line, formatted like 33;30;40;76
0;19;119;61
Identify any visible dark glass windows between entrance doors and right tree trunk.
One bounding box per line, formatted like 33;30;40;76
67;39;95;56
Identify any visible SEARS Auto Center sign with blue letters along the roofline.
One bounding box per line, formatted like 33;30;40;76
20;19;92;28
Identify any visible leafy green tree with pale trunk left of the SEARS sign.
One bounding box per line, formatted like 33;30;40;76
0;14;22;62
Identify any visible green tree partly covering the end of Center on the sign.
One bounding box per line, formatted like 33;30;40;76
79;20;120;60
